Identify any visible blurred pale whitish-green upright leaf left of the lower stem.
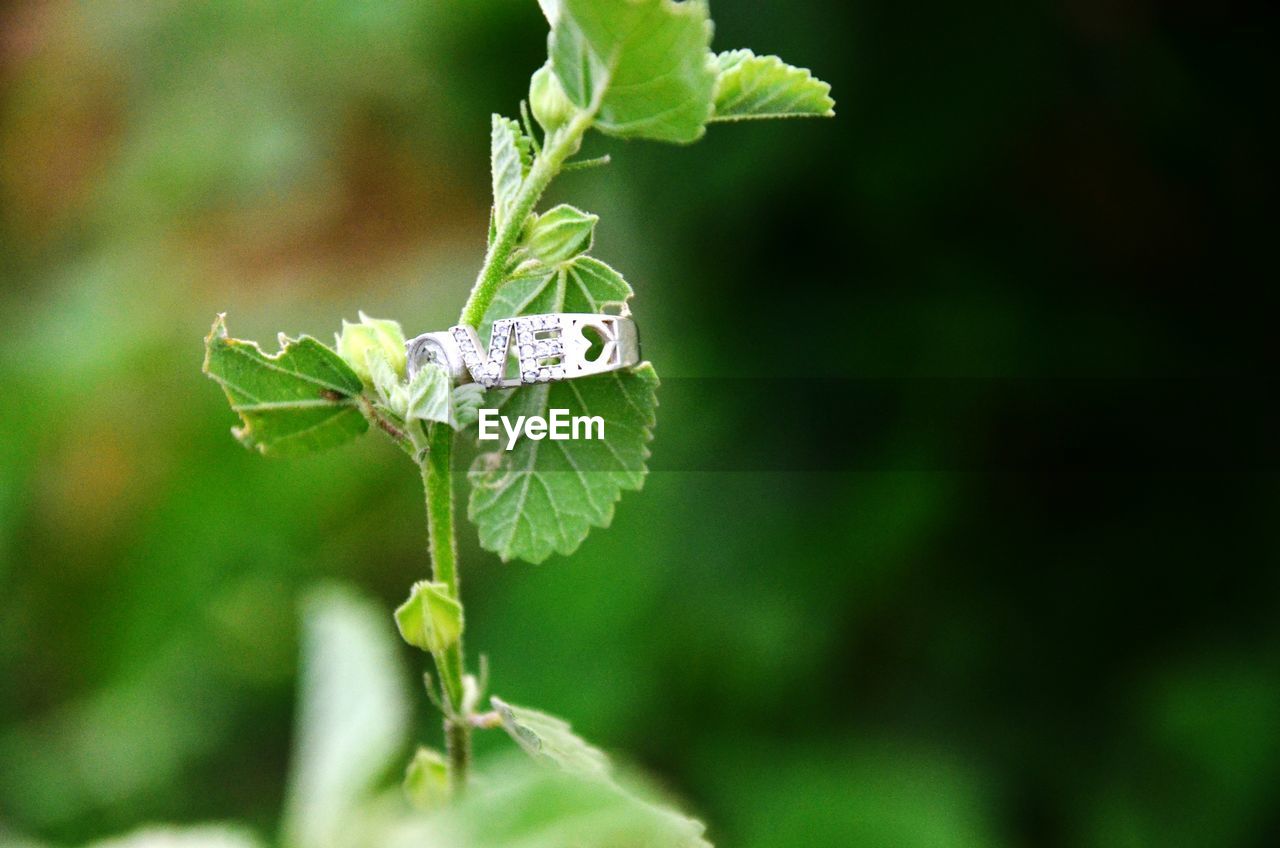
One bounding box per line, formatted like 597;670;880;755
283;585;410;848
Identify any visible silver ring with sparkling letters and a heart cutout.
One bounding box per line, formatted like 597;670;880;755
404;313;640;388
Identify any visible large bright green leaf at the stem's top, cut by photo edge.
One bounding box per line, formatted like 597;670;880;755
544;0;716;142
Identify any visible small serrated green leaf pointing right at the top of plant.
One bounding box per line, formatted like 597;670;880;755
712;50;836;120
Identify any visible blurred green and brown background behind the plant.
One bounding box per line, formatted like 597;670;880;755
0;0;1280;848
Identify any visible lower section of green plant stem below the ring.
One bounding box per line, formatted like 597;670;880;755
421;424;471;794
